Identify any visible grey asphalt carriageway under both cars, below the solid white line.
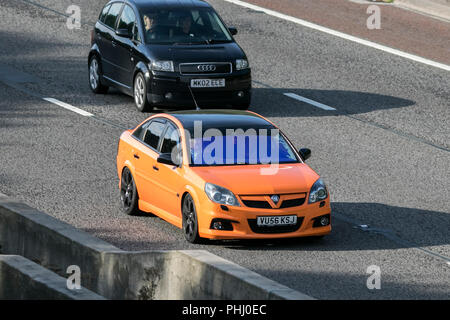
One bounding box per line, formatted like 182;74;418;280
0;0;450;299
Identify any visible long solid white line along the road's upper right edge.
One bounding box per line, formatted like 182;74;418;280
224;0;450;71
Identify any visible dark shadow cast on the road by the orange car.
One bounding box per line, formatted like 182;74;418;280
205;202;450;251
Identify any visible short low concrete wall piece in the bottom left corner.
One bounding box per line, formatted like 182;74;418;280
0;255;104;300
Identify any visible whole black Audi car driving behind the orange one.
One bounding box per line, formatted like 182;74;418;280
88;0;251;112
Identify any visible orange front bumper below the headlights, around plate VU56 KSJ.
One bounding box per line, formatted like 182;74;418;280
198;198;331;239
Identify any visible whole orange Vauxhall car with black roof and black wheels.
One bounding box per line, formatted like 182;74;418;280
117;110;331;243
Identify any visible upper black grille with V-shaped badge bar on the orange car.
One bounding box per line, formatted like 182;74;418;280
240;193;306;209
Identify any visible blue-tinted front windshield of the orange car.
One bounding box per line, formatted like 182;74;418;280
188;134;299;166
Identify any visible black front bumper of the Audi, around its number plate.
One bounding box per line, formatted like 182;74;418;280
147;69;252;108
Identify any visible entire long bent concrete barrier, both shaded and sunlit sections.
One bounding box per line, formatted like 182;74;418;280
0;194;312;300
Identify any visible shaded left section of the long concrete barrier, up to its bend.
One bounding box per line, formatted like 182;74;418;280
0;194;120;295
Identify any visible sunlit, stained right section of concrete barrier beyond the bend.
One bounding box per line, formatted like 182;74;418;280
99;250;312;300
